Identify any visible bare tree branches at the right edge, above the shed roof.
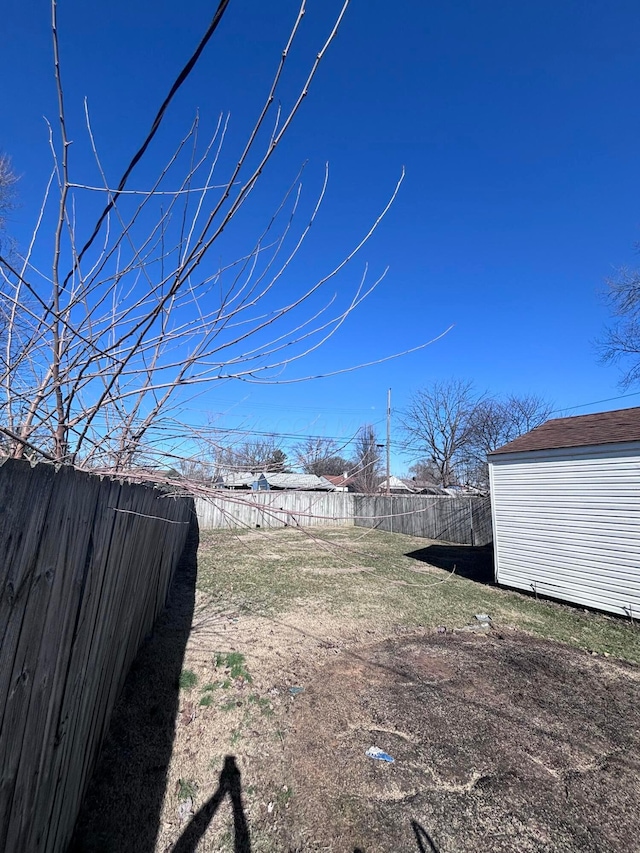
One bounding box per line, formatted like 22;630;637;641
598;269;640;388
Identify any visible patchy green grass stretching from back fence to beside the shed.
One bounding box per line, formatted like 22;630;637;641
198;528;640;664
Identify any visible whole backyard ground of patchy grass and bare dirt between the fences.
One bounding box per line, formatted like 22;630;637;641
74;528;640;853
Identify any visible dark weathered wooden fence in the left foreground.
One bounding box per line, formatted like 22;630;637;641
0;460;193;853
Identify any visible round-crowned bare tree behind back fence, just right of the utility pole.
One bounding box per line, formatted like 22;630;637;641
402;379;478;487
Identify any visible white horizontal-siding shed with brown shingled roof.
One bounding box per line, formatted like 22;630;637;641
489;408;640;618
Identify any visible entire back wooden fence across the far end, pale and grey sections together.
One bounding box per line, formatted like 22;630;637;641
196;491;492;545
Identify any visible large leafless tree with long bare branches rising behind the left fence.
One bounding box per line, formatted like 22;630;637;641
0;0;440;470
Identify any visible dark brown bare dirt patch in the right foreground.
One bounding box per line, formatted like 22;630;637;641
287;632;640;853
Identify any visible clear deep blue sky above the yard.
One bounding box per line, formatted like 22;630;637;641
0;0;640;469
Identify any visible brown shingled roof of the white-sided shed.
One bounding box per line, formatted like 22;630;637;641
489;407;640;456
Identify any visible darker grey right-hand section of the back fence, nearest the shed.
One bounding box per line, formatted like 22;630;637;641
354;495;493;545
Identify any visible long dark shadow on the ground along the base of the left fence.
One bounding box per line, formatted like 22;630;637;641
68;514;199;853
